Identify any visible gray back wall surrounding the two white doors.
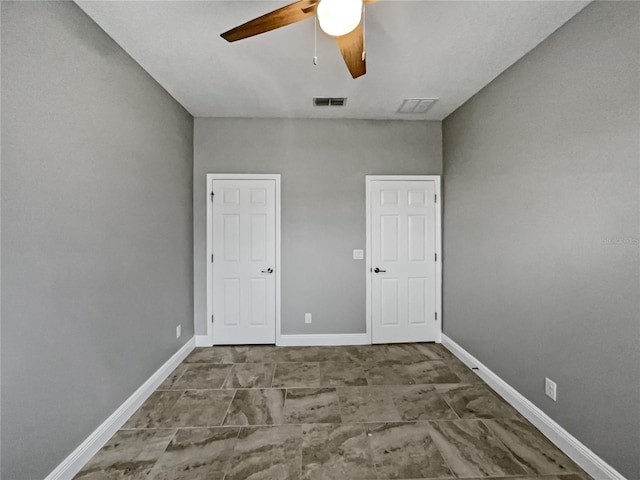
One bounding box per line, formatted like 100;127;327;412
193;118;442;334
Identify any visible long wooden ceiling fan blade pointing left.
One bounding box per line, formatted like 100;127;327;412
220;0;319;42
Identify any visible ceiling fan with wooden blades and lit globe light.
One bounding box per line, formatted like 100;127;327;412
220;0;378;78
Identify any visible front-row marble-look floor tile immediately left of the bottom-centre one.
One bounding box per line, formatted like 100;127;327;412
225;425;302;480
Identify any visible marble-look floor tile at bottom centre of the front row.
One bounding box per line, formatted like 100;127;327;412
302;424;377;480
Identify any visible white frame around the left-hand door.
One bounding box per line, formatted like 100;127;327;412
205;173;281;346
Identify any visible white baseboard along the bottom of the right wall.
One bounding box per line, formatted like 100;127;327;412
442;333;626;480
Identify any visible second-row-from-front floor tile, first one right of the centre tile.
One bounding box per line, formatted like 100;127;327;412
337;387;400;423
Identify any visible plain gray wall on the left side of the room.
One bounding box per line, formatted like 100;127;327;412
1;2;193;480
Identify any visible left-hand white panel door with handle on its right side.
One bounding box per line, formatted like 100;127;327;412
212;179;276;345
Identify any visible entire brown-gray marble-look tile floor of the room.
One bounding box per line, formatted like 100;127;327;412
75;343;590;480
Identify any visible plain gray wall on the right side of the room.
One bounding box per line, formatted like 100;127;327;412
443;2;640;480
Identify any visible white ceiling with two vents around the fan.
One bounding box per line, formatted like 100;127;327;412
76;0;588;120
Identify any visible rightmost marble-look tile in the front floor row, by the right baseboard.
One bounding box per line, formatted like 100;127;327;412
484;419;582;475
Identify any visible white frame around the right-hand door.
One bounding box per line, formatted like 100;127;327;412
365;175;442;343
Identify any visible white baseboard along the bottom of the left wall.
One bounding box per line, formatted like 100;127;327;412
45;338;195;480
